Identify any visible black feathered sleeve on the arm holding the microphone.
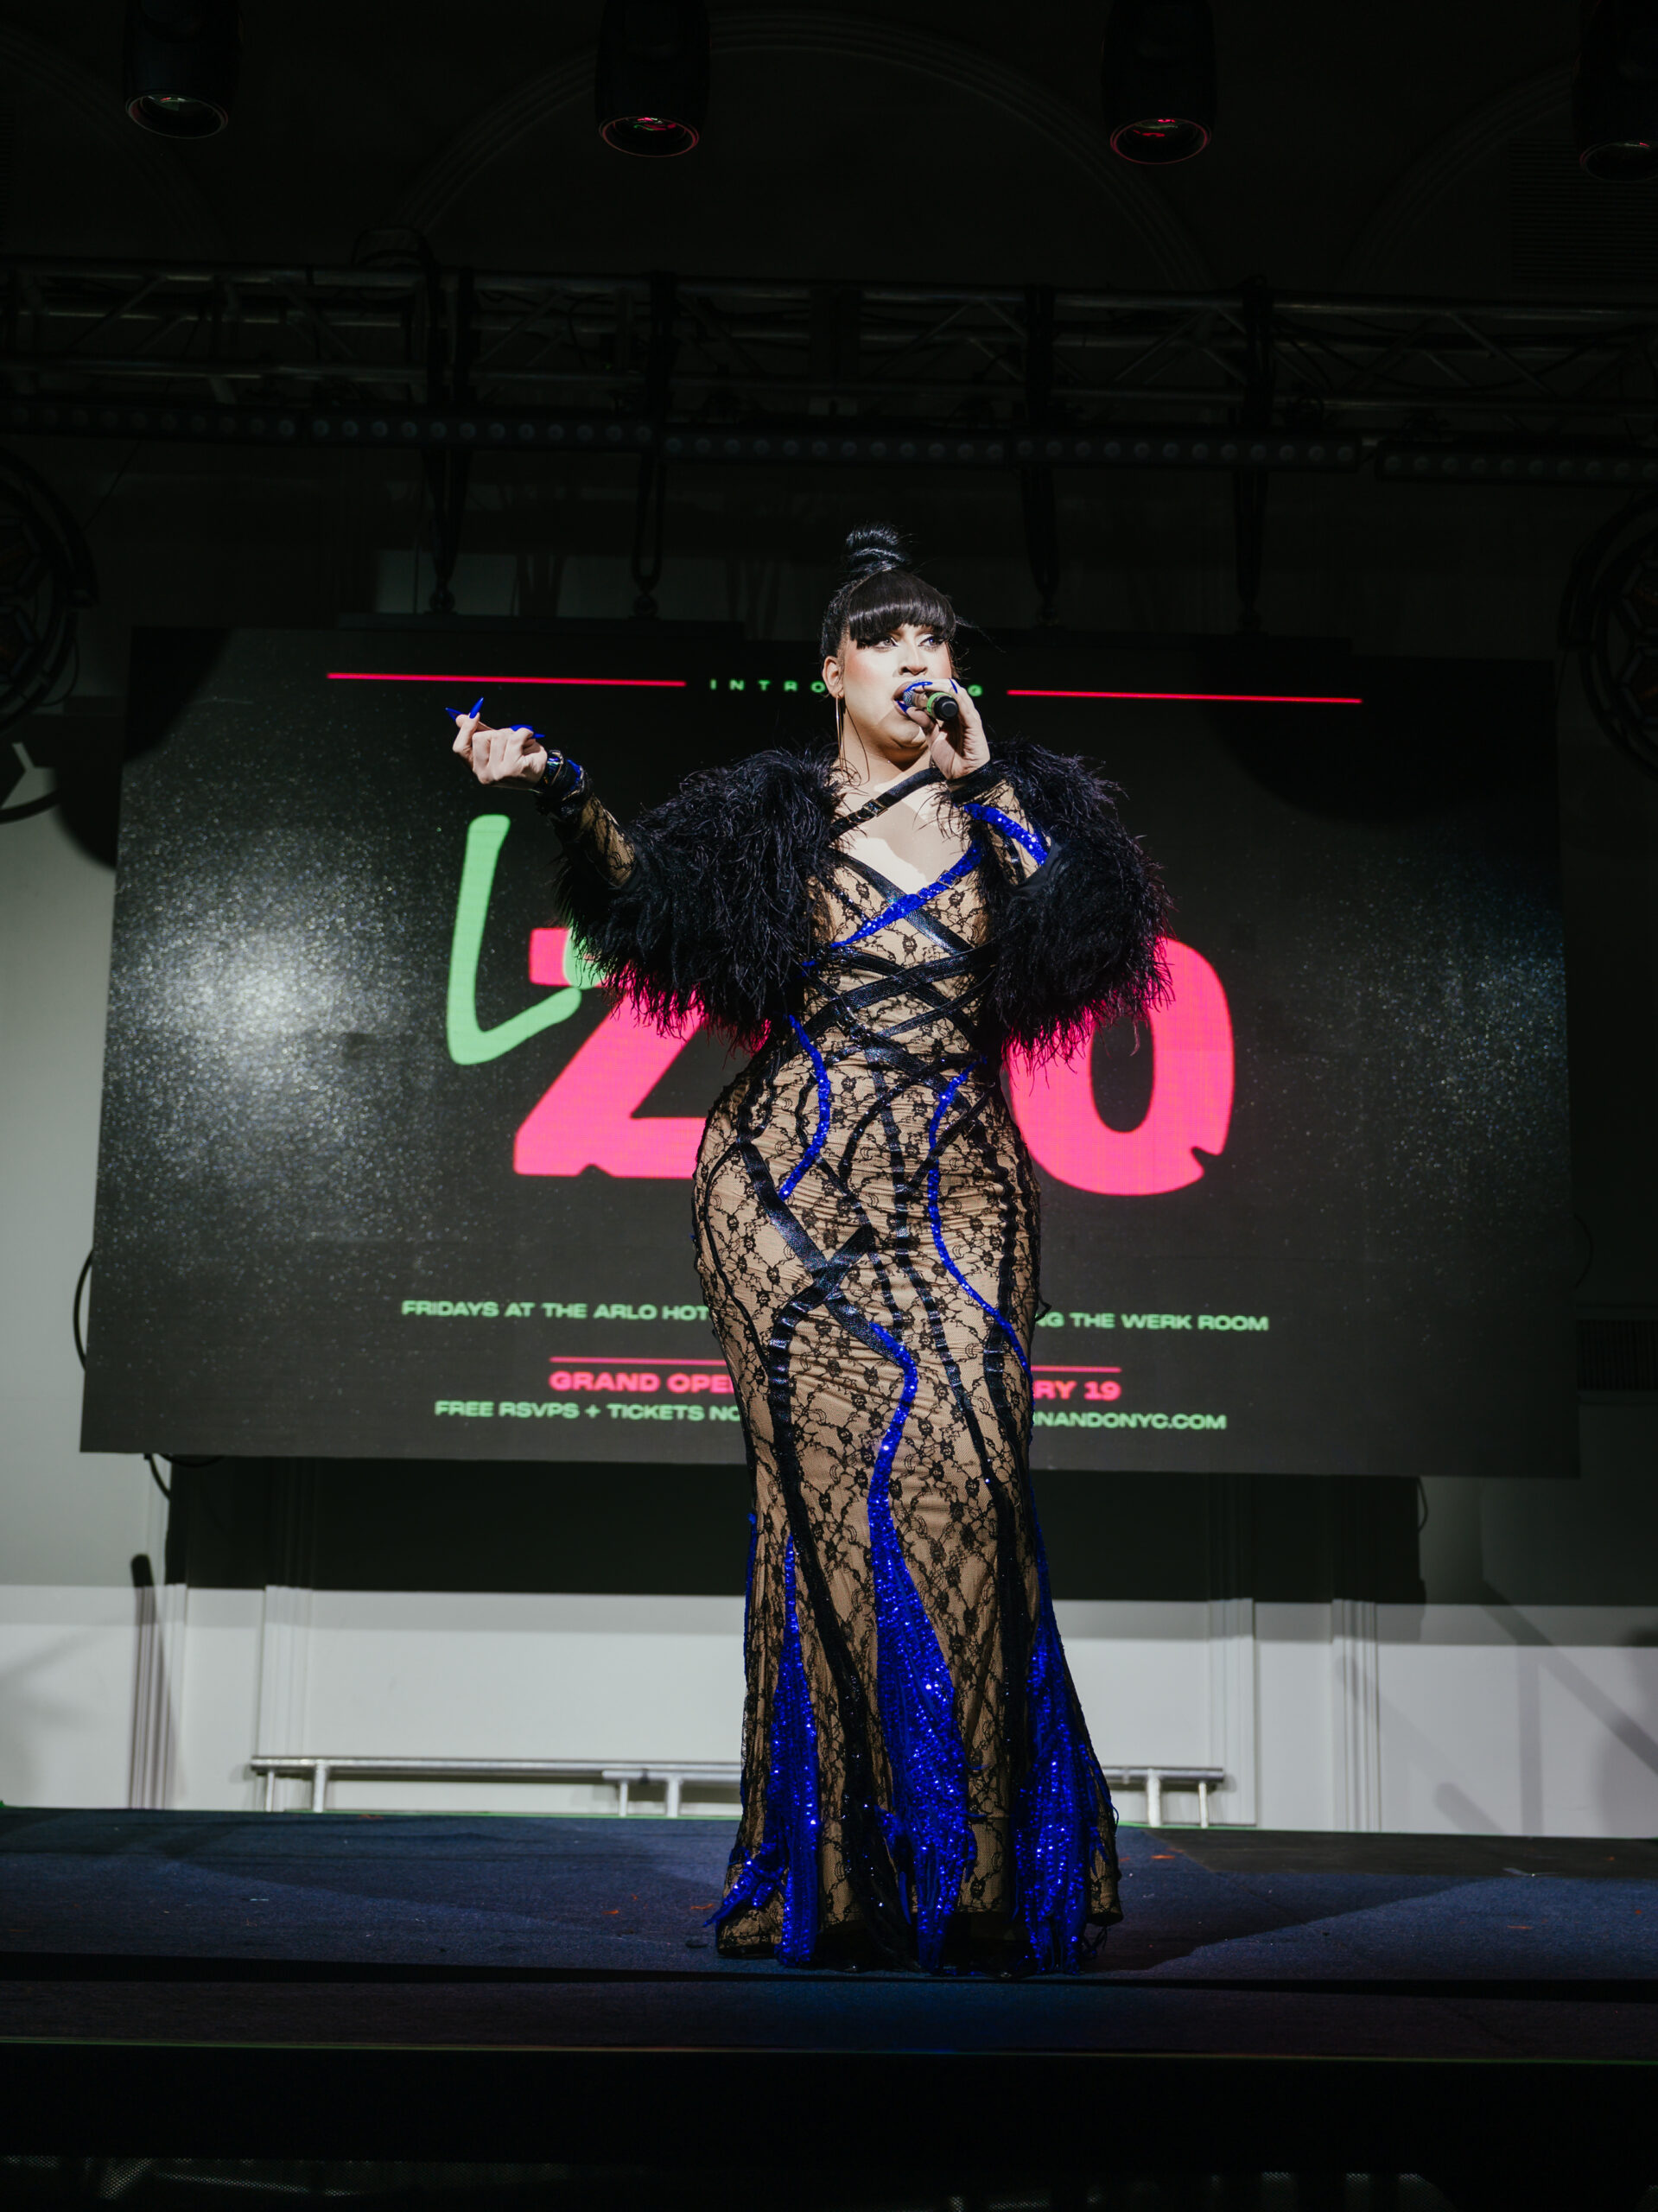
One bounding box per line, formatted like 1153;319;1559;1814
950;746;1170;1059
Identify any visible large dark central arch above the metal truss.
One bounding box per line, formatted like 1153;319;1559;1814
384;9;1210;289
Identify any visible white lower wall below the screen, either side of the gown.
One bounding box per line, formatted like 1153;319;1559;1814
0;1586;1658;1836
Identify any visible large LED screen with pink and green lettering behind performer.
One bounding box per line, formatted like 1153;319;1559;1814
84;631;1574;1473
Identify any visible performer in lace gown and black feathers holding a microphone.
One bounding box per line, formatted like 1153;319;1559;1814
455;531;1163;1974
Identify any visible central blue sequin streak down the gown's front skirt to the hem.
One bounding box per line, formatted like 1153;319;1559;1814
869;1320;975;1974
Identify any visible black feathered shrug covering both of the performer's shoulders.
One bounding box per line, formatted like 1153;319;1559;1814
559;739;1167;1059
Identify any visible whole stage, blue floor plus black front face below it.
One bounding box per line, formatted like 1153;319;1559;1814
0;1809;1658;2170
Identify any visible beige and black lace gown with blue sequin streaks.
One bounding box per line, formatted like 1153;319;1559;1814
563;767;1119;1971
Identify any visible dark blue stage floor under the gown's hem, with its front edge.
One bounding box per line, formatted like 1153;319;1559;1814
0;1812;1658;2059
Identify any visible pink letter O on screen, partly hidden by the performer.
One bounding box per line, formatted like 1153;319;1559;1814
1008;940;1231;1199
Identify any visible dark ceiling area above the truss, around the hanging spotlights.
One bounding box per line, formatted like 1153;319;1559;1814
0;0;1591;294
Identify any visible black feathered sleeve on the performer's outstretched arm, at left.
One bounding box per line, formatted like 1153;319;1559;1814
553;754;823;1042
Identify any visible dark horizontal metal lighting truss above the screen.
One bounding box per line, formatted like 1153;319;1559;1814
0;252;1658;485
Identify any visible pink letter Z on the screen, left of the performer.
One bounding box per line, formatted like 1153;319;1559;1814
513;1000;703;1181
